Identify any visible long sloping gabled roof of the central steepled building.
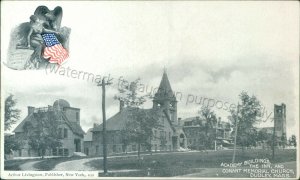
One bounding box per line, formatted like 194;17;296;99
92;107;173;132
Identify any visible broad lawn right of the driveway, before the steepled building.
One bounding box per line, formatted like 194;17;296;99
86;149;296;177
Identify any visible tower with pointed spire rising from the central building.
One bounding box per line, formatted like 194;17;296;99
153;70;178;125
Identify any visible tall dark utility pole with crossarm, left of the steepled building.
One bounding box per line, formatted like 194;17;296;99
98;77;112;175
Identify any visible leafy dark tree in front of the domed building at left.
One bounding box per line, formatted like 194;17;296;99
23;111;62;158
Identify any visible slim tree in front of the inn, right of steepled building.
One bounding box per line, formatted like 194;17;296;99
198;106;217;149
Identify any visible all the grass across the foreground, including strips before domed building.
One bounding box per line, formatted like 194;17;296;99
4;149;296;177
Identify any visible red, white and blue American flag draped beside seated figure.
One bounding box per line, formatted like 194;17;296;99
42;33;69;65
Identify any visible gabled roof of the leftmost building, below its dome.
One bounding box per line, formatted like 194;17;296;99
13;111;85;136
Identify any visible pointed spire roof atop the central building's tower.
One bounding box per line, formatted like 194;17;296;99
154;69;176;100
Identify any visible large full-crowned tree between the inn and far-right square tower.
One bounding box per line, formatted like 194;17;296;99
228;92;262;150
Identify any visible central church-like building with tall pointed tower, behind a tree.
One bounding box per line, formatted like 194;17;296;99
84;72;187;155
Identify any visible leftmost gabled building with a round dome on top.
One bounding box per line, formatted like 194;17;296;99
13;99;85;157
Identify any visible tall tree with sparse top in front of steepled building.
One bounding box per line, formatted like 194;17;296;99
115;79;160;158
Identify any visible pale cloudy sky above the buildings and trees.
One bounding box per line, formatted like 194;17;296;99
1;1;299;136
